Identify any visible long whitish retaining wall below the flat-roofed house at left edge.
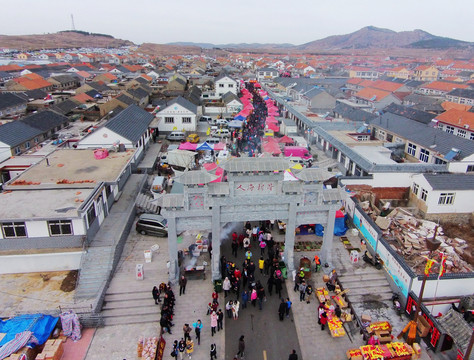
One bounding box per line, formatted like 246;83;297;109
0;251;83;274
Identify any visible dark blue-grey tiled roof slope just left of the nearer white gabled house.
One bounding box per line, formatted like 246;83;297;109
105;105;154;144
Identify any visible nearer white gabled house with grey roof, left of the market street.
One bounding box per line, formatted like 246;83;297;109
156;96;197;133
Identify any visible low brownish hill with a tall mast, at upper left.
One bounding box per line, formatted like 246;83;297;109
0;31;133;51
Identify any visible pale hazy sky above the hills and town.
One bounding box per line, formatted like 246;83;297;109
0;0;474;46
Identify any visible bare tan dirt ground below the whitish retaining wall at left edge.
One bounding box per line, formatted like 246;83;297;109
0;271;77;318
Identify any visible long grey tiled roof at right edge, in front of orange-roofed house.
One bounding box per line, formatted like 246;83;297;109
370;113;474;158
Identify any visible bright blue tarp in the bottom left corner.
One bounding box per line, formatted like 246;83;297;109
0;314;59;346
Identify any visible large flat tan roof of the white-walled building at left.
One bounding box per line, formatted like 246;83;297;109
4;149;135;190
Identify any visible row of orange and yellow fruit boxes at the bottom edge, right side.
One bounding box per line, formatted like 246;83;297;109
346;342;419;360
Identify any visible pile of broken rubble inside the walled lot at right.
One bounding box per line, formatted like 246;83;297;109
363;204;473;274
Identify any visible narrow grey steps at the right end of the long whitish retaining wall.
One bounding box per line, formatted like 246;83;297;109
75;246;113;299
